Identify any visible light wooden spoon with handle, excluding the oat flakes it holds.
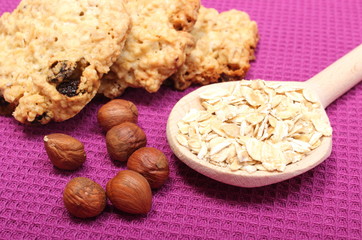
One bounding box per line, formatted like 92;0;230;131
167;44;362;187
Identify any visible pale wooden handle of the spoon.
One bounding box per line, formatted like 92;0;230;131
306;44;362;108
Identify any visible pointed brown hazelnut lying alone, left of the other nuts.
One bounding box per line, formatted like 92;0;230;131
44;133;86;170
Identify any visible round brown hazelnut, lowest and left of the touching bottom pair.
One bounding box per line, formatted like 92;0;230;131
63;177;107;218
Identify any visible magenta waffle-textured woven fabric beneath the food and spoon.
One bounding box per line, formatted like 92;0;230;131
0;0;362;239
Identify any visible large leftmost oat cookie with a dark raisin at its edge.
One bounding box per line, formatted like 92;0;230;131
0;0;130;124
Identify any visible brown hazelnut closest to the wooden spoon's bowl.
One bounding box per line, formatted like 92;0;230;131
127;147;170;188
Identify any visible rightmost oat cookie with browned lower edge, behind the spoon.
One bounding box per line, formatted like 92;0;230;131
170;7;258;90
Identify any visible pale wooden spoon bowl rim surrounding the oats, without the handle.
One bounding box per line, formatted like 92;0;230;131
167;81;332;187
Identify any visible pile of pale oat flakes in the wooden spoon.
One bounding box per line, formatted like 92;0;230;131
177;80;332;173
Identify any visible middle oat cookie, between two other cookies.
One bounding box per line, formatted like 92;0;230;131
99;0;200;98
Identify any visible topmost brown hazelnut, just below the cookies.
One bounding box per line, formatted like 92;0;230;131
97;99;138;131
